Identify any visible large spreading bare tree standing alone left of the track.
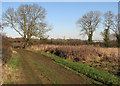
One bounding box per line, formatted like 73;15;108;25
3;4;49;47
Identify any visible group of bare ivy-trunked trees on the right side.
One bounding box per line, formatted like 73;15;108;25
77;11;120;47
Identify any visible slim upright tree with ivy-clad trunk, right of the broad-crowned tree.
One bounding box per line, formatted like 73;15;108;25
103;11;114;47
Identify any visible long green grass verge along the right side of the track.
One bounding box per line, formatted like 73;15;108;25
36;51;120;85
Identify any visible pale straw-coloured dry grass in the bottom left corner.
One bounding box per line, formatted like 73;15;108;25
2;64;23;84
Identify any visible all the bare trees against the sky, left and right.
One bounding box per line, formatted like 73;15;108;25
2;4;120;47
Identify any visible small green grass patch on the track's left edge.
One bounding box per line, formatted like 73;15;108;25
8;53;19;69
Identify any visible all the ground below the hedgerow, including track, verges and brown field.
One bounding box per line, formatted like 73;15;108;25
2;38;120;85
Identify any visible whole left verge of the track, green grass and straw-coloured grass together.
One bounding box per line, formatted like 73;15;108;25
2;53;22;84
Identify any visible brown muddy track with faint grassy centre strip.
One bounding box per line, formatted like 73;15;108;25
16;49;88;84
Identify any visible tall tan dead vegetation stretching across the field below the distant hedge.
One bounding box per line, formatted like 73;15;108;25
27;45;118;62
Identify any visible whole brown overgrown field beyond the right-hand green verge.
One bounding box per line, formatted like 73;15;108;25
27;45;119;75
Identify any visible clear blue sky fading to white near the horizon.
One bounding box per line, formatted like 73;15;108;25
2;2;118;40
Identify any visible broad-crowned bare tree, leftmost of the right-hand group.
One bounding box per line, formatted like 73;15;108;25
77;11;101;43
